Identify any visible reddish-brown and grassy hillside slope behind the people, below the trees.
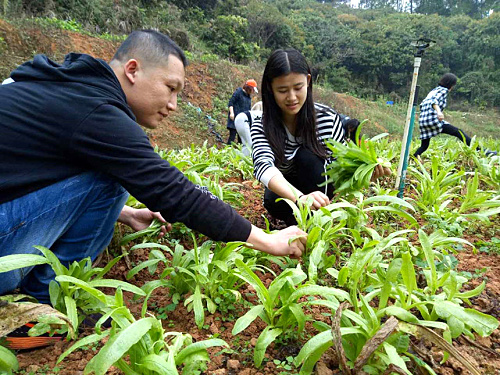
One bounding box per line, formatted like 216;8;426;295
0;19;500;148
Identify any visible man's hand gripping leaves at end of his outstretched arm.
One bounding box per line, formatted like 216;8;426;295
246;225;307;258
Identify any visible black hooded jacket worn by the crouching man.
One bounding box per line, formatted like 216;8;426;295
0;54;251;241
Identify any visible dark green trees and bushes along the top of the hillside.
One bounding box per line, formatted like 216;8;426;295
2;0;500;109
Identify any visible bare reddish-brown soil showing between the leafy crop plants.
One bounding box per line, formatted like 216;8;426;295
13;181;500;375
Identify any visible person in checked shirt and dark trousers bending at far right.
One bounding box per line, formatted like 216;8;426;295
414;73;497;158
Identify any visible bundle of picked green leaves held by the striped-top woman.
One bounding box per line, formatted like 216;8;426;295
326;120;391;194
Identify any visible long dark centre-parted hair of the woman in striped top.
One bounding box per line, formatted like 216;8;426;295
261;49;328;166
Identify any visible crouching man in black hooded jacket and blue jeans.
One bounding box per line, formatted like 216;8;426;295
0;30;305;303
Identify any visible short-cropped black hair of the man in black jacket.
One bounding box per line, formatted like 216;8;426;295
111;30;188;67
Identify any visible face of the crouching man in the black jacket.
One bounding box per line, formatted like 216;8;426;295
126;55;185;129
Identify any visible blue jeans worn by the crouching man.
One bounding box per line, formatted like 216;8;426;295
0;172;128;303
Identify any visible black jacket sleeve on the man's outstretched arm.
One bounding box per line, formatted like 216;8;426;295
66;105;251;241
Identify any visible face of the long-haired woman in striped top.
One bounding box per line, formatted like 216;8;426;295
271;73;311;119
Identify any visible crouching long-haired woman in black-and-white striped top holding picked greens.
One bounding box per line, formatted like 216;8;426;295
250;49;390;225
